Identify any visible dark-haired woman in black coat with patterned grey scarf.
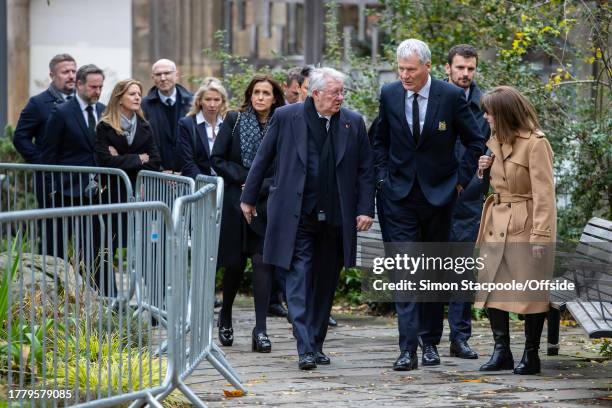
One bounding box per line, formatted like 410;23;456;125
212;75;285;353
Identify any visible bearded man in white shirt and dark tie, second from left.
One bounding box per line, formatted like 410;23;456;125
41;64;115;295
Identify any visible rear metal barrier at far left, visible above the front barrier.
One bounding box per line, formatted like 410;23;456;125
0;163;134;212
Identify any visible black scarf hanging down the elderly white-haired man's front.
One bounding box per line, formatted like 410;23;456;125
304;97;342;226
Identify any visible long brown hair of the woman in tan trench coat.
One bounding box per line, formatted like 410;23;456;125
480;85;540;144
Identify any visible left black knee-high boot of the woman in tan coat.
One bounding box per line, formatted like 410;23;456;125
480;308;514;371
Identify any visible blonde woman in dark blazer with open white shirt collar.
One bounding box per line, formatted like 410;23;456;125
176;77;227;180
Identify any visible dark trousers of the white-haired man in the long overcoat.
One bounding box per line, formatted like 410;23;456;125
283;214;344;354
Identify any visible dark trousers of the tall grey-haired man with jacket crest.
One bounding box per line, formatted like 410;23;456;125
382;183;454;351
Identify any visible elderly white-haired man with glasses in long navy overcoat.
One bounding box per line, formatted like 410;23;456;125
241;68;374;370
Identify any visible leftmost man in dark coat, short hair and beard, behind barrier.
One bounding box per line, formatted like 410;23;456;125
13;54;77;208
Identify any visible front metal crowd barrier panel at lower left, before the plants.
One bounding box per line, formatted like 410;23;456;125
0;202;174;407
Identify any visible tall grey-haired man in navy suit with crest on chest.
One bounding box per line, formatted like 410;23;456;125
374;39;484;370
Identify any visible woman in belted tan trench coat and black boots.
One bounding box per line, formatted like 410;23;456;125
476;86;557;374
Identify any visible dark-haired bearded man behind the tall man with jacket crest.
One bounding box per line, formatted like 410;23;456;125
445;44;490;359
